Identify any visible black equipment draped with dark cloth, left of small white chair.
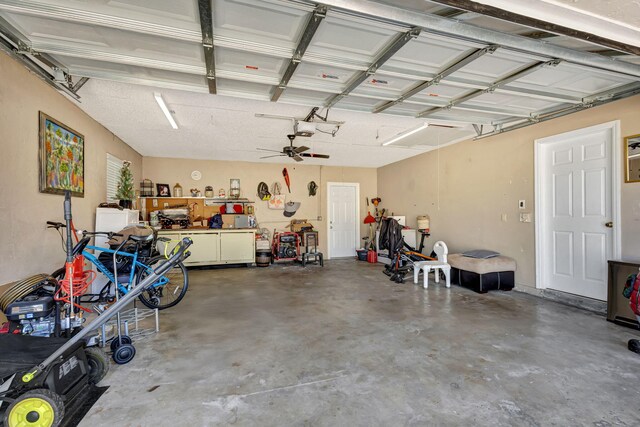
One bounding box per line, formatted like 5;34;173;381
379;218;436;283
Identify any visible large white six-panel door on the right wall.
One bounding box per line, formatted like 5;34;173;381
538;126;617;300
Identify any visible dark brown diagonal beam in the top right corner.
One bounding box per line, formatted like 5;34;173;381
420;0;640;55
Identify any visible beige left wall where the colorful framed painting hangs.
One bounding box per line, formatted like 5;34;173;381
0;52;142;284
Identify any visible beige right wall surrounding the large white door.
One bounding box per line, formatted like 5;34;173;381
378;96;640;287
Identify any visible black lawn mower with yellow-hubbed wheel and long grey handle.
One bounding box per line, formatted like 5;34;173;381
0;237;192;427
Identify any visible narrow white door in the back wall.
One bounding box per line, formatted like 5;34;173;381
328;184;360;258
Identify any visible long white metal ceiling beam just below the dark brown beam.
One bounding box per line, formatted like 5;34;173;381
319;0;640;77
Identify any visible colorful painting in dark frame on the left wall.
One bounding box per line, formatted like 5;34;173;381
39;111;84;197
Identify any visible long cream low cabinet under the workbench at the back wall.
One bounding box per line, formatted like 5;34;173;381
158;230;256;266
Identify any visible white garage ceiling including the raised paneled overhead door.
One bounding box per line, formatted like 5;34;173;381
0;0;640;166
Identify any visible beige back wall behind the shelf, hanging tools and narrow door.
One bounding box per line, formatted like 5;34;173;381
142;157;377;256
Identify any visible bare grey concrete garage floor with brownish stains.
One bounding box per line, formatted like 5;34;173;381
81;260;640;427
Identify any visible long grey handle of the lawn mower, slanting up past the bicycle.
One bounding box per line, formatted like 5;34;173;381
21;237;193;383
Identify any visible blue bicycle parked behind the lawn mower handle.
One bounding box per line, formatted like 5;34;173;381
47;221;189;310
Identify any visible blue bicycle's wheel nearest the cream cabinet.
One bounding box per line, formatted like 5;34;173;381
136;256;189;310
